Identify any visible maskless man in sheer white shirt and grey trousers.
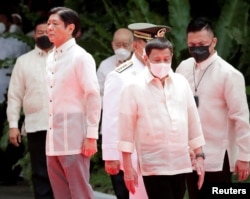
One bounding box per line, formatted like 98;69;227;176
46;7;101;199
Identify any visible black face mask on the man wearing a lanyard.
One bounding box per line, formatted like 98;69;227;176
188;46;210;63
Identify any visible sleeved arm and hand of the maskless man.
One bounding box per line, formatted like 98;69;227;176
77;53;101;157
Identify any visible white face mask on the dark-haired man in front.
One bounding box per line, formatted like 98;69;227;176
150;62;171;79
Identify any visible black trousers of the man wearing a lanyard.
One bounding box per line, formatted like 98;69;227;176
186;152;232;199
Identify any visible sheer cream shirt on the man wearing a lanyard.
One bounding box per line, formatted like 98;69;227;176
176;53;250;171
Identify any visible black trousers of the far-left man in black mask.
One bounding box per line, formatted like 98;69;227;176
27;131;54;199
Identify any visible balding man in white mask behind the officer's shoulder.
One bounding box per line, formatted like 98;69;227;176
97;28;133;96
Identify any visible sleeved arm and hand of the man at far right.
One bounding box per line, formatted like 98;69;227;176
225;72;250;181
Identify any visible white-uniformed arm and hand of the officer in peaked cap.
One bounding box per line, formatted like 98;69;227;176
102;71;123;174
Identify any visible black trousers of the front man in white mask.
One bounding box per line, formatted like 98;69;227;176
143;174;186;199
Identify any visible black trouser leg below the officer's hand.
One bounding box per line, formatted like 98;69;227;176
110;170;129;199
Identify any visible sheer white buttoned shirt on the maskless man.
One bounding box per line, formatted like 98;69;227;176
46;38;101;156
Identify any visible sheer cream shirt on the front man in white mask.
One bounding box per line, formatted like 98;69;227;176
118;68;205;176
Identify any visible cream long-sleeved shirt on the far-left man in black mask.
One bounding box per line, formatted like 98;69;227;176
7;47;48;133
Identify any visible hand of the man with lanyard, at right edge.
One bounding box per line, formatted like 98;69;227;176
234;160;250;181
